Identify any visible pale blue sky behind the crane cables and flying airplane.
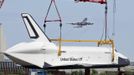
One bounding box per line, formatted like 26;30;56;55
0;0;134;61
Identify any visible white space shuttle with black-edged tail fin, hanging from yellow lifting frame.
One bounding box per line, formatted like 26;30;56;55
4;13;130;69
